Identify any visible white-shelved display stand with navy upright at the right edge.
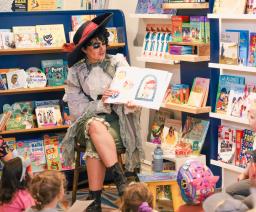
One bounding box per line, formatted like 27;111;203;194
208;0;256;189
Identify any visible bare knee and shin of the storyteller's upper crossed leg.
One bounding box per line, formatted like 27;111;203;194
88;121;117;167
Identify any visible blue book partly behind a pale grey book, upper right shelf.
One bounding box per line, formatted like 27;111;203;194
226;29;249;66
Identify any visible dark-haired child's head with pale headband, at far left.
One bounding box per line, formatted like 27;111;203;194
0;157;27;204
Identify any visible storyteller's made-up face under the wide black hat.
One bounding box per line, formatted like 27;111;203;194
82;37;107;63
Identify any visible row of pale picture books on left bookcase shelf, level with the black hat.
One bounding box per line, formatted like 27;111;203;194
0;24;66;49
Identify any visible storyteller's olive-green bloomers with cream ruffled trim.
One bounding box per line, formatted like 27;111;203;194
76;112;124;159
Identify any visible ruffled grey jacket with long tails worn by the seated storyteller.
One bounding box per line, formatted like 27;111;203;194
62;54;144;171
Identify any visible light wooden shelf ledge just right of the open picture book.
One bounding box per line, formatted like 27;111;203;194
162;103;211;114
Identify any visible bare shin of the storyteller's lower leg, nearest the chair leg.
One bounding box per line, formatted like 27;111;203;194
86;157;106;191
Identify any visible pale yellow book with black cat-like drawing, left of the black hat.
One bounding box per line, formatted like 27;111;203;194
36;24;66;47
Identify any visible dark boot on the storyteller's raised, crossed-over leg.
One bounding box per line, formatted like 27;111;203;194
108;162;127;196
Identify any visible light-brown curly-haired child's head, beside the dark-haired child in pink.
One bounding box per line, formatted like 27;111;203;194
29;171;66;210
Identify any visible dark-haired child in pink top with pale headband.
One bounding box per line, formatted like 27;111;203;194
0;157;34;212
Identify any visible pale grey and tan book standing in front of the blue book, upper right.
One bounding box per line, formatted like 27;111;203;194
219;32;240;65
